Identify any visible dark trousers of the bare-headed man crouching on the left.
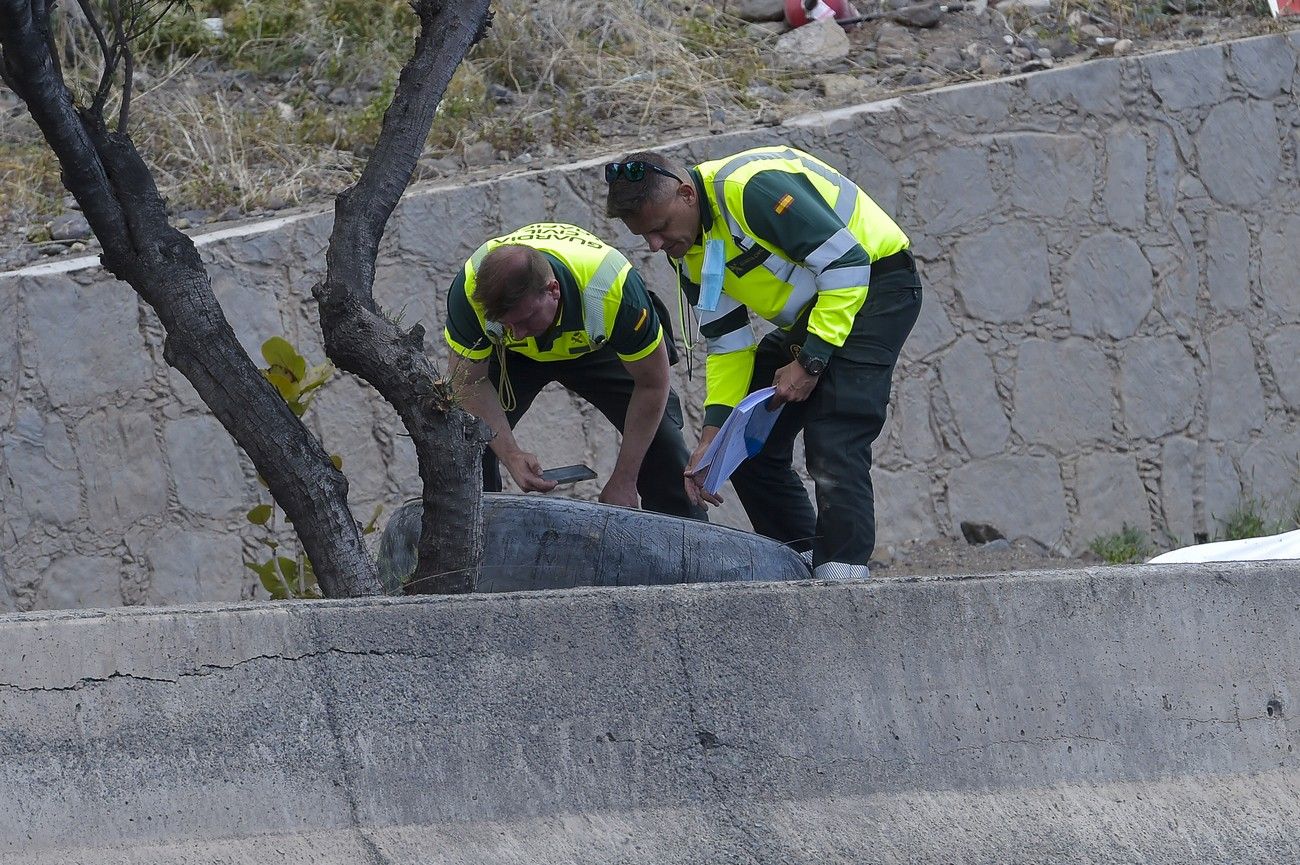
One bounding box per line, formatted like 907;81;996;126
484;349;707;520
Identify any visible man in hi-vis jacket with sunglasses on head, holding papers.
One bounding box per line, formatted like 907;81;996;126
605;147;920;579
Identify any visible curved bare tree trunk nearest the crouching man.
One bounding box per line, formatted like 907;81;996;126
313;0;489;592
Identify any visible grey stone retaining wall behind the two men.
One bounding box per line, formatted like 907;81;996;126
0;34;1300;610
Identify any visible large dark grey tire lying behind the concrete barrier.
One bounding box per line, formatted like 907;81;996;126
378;493;811;594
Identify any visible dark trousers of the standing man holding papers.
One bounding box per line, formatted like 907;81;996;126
732;269;920;567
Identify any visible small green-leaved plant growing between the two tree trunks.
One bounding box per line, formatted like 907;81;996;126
244;337;384;601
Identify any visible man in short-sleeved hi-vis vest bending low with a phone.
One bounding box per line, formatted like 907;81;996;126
445;222;705;519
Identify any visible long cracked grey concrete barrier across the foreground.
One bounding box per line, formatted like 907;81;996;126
0;562;1300;865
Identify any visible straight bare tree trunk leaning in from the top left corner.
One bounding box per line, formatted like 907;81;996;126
0;0;382;597
